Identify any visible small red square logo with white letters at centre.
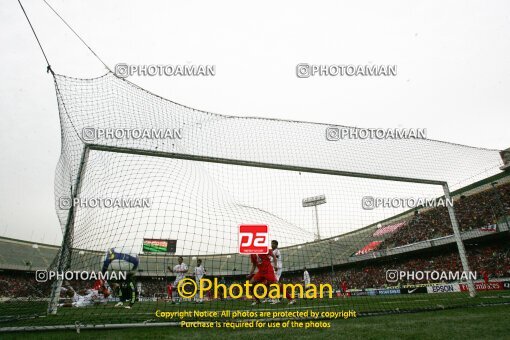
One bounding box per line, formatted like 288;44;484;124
239;224;269;254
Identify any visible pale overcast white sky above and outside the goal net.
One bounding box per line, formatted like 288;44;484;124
0;0;510;244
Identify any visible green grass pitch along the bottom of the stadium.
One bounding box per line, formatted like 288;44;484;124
0;291;510;340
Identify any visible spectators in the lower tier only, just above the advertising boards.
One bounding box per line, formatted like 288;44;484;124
0;243;510;298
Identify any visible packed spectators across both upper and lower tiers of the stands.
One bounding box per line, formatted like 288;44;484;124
0;184;510;298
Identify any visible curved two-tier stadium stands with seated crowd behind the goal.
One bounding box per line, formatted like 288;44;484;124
0;173;510;297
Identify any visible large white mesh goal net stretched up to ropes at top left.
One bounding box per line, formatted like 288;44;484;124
1;73;510;327
